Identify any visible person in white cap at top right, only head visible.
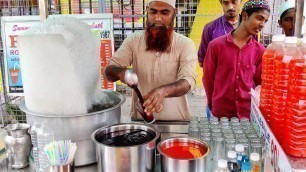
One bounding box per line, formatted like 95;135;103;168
278;0;295;36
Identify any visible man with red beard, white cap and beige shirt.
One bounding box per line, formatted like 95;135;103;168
104;0;197;121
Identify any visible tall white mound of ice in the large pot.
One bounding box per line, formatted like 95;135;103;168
18;16;102;116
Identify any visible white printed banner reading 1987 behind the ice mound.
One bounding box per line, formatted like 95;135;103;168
1;14;116;96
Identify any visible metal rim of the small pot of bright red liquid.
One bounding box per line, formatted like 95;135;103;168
157;136;210;161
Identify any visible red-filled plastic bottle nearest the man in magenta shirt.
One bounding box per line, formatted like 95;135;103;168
259;35;285;124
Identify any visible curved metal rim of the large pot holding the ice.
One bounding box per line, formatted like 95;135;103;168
19;89;126;118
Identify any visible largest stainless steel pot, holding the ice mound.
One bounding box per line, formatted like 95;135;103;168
20;90;125;166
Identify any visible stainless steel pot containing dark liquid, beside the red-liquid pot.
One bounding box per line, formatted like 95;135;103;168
91;123;160;172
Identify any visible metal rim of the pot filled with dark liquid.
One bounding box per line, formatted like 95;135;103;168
91;123;160;148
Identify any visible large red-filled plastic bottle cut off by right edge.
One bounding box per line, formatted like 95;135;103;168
282;38;306;158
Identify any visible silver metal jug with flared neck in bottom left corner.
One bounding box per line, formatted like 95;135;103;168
4;124;32;169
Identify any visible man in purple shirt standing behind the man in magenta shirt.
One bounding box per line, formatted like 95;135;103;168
198;0;242;67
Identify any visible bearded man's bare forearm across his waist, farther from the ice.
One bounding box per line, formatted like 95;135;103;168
162;79;191;97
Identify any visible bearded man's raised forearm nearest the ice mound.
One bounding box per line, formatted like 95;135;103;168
104;65;127;82
